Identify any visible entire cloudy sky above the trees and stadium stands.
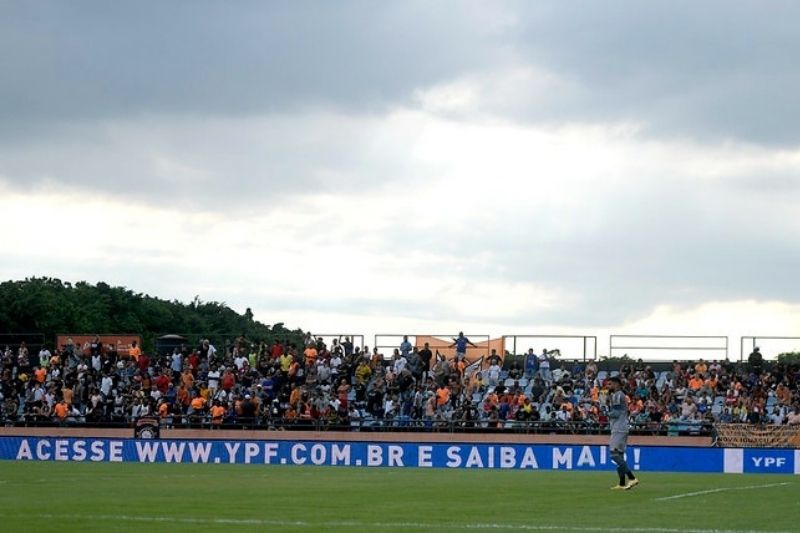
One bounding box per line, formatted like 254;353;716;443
0;1;800;357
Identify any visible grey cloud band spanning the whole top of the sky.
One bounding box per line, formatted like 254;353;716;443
0;1;800;144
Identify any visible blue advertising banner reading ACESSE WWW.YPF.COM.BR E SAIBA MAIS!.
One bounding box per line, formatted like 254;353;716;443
0;437;798;473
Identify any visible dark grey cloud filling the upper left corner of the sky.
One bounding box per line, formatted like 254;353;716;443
0;1;510;129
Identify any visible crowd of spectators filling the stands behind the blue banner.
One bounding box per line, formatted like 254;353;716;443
0;335;800;431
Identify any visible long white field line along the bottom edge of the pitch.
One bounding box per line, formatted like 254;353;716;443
6;513;791;533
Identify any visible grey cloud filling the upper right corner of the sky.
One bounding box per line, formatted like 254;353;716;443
490;1;800;144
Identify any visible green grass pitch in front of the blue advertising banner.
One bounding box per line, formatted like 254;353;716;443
0;461;800;533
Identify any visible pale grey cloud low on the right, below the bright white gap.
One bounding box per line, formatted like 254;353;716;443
376;172;800;327
